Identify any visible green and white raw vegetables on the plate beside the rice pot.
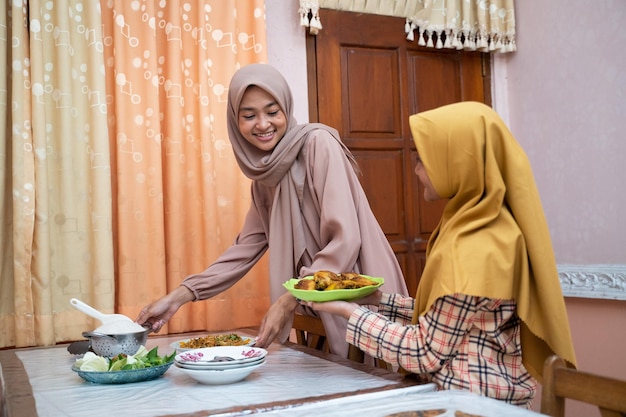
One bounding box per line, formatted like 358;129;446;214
75;346;176;372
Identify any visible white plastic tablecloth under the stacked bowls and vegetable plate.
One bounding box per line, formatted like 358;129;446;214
16;338;434;417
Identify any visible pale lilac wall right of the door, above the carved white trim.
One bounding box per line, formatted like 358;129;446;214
495;0;626;264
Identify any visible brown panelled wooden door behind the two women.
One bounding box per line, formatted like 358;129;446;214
307;9;490;294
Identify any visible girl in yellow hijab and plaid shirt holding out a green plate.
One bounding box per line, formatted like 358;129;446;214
308;102;576;407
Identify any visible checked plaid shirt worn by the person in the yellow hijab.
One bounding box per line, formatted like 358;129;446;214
346;294;536;406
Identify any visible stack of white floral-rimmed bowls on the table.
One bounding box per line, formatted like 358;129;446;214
174;346;267;385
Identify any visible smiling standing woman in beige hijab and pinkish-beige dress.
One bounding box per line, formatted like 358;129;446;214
137;64;407;357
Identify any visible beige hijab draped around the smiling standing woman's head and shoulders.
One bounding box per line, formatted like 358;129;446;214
227;64;356;301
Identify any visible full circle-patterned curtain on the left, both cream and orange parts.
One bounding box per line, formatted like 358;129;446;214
0;0;269;348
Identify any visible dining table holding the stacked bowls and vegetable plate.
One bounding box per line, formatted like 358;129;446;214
0;329;428;417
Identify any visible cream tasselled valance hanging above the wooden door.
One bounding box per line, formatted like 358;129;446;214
300;0;516;52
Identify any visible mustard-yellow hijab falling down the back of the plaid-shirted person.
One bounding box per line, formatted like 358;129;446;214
409;102;576;382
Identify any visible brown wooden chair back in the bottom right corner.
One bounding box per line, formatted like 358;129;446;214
541;355;626;417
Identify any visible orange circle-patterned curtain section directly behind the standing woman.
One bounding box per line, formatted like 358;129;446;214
101;0;269;333
